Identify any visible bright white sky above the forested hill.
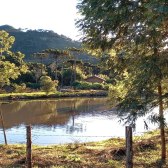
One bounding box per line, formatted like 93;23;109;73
0;0;80;40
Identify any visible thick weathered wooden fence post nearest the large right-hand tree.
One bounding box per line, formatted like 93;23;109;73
125;126;133;168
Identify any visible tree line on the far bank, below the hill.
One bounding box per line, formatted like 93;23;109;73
0;30;113;92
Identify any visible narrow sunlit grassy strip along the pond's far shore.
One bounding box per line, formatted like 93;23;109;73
0;90;108;100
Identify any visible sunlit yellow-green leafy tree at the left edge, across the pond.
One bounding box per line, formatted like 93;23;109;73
0;30;27;88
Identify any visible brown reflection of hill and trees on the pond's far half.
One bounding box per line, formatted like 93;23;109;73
0;98;107;128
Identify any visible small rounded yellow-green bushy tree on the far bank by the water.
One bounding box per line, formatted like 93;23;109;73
40;76;58;95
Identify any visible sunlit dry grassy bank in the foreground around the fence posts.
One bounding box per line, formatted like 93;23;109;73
0;130;168;168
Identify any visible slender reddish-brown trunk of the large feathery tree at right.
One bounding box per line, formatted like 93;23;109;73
158;84;166;160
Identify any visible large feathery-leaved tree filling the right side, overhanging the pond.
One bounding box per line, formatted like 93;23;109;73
76;0;168;159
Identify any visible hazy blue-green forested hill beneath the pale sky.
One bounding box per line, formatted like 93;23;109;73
0;25;97;64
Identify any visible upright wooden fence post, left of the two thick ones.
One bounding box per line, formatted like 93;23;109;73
26;125;32;168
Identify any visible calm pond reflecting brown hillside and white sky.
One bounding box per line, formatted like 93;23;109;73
0;97;162;145
